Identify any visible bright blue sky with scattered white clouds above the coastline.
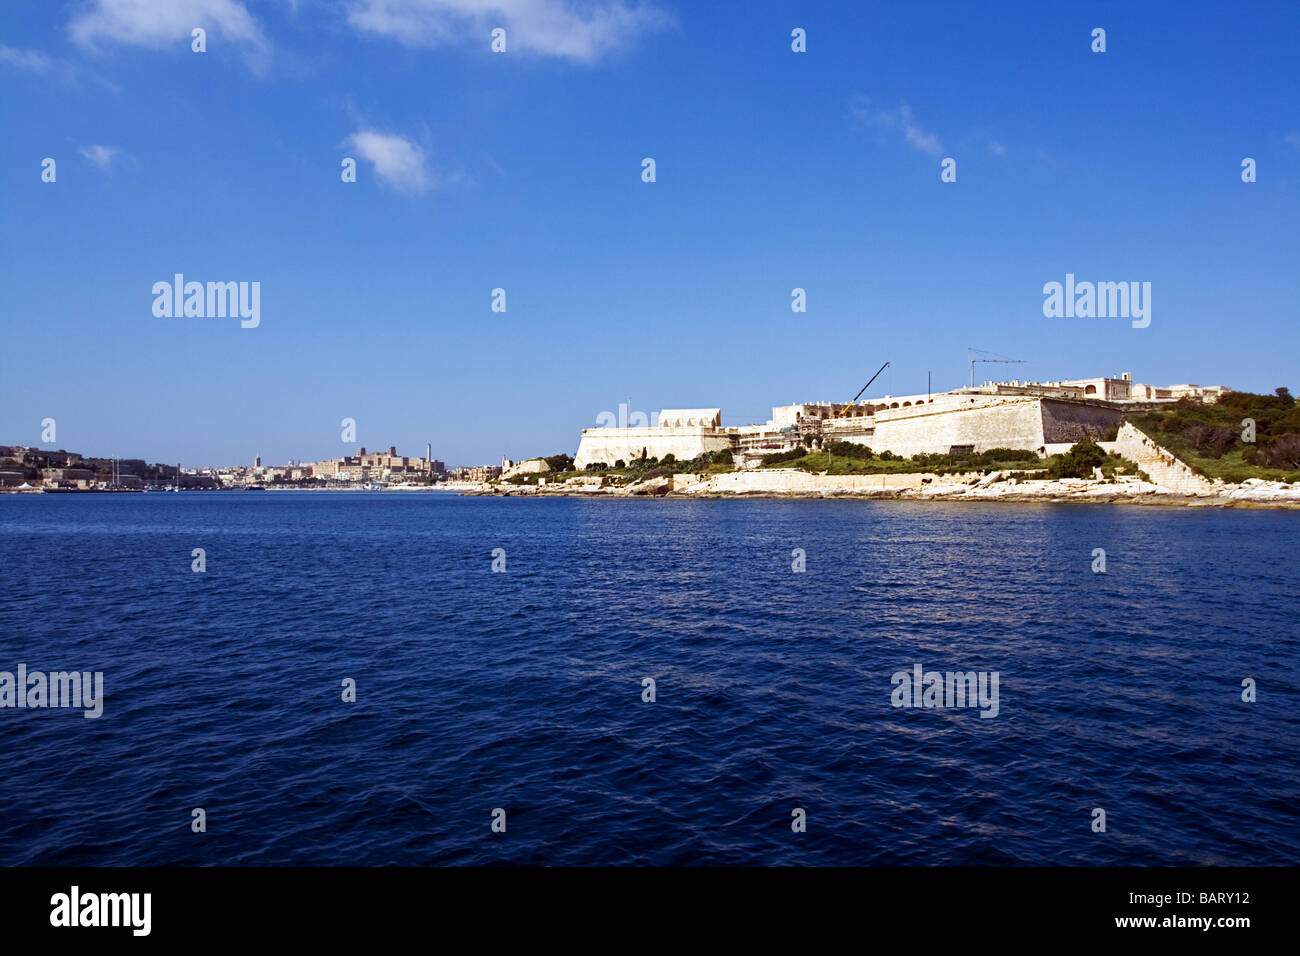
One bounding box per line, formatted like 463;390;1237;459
0;0;1300;466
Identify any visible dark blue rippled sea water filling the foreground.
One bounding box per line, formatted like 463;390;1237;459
0;492;1300;865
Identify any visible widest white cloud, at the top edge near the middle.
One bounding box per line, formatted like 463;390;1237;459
347;0;672;62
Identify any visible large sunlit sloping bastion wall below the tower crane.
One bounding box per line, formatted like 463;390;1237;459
871;398;1044;455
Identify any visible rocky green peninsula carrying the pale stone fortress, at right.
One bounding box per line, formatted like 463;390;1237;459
481;373;1300;507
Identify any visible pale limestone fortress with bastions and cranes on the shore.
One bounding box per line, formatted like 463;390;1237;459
575;372;1227;470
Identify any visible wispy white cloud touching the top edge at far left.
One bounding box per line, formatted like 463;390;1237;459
68;0;269;65
